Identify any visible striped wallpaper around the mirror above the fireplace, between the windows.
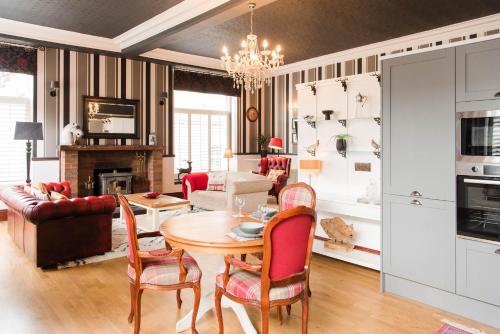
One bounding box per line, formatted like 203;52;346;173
36;48;174;157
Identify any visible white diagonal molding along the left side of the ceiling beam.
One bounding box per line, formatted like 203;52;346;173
113;0;231;49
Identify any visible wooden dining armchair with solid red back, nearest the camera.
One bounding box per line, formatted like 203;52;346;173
215;206;316;334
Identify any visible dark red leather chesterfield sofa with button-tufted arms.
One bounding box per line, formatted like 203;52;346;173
0;182;116;267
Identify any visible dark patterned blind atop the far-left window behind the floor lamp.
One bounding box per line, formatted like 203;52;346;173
0;44;36;75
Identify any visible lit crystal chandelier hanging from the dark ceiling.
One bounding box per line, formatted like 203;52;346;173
221;2;283;93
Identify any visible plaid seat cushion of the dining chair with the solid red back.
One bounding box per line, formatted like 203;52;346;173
216;270;304;301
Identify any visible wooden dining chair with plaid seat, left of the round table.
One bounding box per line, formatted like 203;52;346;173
118;194;202;334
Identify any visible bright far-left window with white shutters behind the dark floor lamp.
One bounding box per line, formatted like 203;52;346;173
0;72;33;182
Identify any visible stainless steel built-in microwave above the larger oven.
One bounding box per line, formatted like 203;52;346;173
456;110;500;163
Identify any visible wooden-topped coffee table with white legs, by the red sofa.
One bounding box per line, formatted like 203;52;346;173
120;193;190;231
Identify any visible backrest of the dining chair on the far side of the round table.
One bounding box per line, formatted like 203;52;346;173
278;182;316;211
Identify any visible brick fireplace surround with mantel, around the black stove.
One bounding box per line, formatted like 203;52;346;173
59;145;164;196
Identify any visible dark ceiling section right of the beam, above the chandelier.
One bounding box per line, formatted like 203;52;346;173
162;0;500;64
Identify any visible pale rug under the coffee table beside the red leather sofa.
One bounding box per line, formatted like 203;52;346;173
52;208;205;269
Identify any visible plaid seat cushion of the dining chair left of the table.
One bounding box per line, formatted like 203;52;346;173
128;250;201;285
